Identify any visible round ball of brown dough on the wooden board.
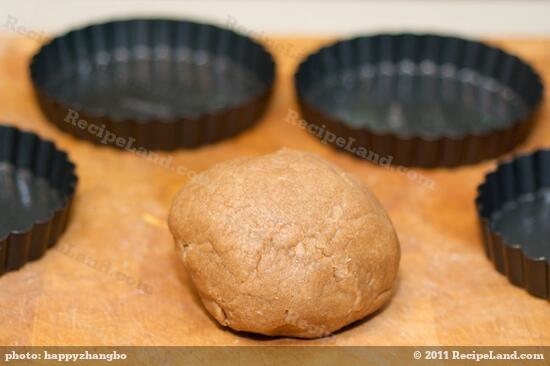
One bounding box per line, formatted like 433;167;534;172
168;149;400;338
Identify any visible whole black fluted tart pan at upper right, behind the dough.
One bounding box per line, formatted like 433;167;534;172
295;34;543;167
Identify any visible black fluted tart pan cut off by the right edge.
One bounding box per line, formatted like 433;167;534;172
476;150;550;299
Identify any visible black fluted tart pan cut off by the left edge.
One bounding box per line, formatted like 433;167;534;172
0;125;77;275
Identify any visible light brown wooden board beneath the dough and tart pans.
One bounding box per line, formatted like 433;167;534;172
0;34;550;345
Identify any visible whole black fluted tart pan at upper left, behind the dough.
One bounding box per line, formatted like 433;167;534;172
30;19;275;150
